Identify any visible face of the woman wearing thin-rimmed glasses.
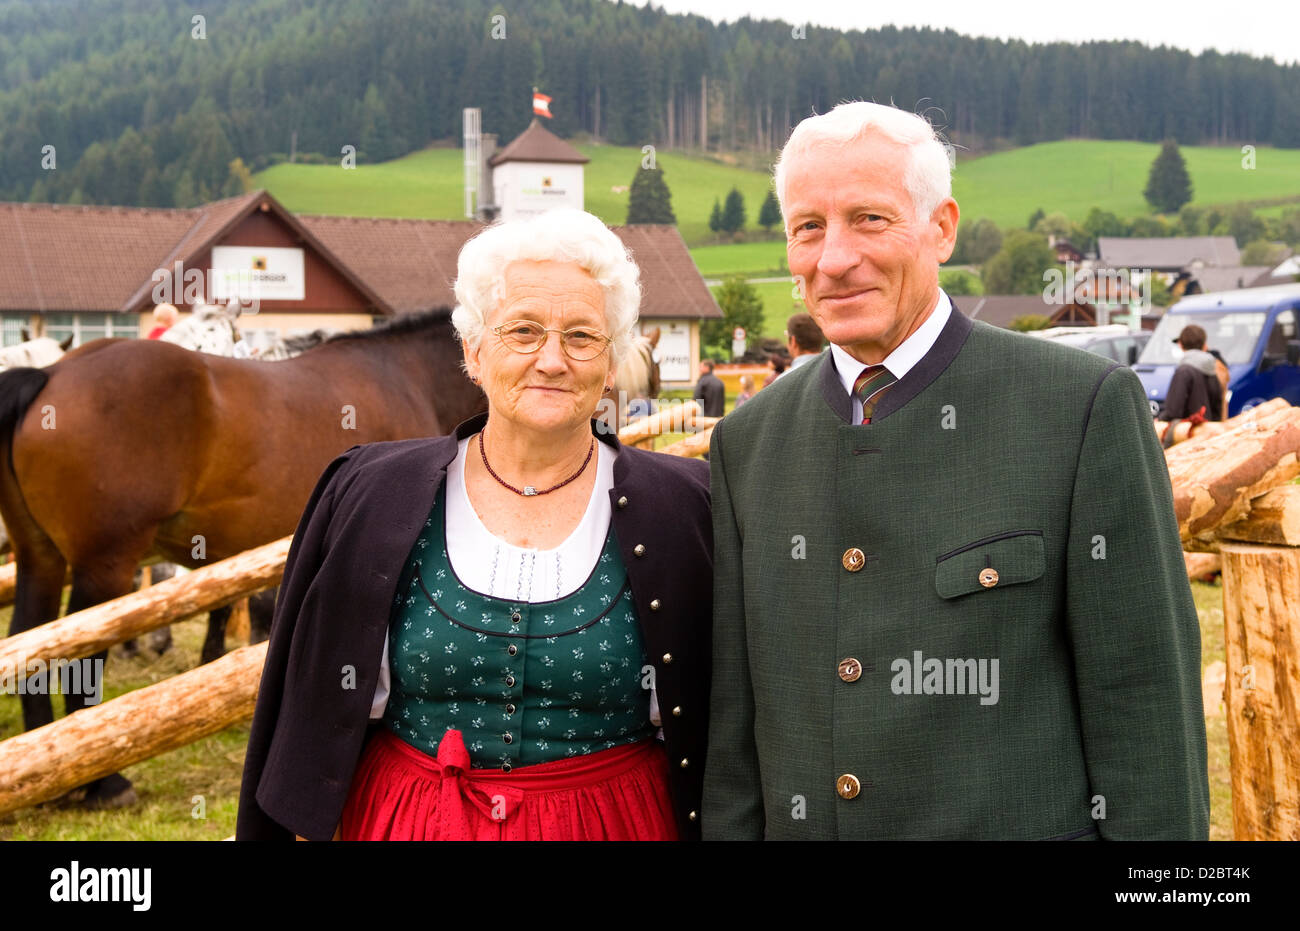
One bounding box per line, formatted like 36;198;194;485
465;260;614;430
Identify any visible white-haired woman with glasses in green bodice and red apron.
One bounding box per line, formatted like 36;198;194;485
237;209;712;840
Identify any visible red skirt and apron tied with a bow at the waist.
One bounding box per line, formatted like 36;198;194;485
339;729;677;840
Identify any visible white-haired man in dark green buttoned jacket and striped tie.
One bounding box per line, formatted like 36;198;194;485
699;103;1209;839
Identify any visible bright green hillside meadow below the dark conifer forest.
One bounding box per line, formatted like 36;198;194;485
255;139;1300;250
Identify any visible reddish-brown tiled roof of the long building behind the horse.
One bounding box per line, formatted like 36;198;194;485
0;191;722;319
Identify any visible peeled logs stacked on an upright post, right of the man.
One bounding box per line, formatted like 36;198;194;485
1165;399;1300;840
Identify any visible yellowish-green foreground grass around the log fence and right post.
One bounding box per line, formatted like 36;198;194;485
0;572;1232;843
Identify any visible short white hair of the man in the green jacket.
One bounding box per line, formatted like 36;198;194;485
774;100;953;231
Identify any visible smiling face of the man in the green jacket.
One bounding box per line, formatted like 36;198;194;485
785;139;958;364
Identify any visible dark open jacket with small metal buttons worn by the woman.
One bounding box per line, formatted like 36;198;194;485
235;415;712;840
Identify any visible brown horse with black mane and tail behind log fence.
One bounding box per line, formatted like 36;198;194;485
0;309;486;805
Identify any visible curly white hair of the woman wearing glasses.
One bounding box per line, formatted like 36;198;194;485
451;207;641;365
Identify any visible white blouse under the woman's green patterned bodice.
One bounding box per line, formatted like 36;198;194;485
371;437;662;727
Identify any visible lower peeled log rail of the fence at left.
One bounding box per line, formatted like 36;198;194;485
0;639;267;814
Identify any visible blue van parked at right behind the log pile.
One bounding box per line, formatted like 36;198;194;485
1134;285;1300;417
